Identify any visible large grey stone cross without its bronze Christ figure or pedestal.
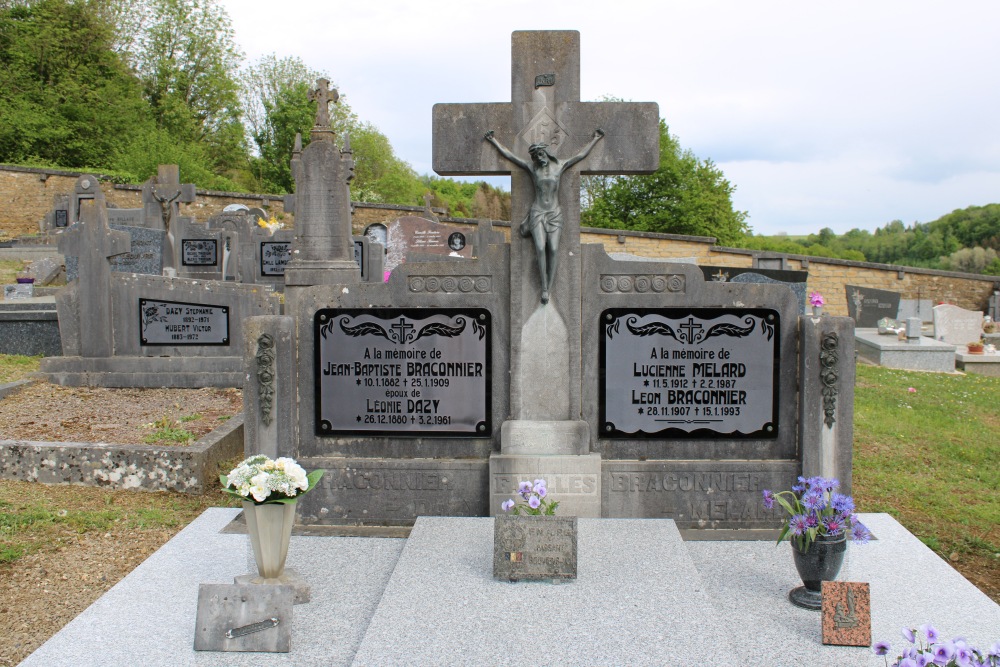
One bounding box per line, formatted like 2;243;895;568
433;31;659;420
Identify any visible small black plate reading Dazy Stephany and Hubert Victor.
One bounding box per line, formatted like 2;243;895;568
139;299;229;345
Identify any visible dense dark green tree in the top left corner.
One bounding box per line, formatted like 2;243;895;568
0;0;152;168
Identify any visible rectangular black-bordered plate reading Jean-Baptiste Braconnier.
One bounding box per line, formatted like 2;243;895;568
313;308;492;437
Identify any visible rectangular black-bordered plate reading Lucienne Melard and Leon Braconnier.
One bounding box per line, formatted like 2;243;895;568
600;308;781;439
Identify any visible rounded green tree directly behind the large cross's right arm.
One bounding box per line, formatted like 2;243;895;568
581;119;748;245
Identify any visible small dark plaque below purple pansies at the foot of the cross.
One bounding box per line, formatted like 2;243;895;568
493;514;577;581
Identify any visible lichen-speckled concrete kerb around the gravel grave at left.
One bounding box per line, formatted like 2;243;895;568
0;394;243;494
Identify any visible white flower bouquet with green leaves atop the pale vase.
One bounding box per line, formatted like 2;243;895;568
219;454;323;505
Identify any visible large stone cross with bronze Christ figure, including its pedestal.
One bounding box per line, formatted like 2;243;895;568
433;31;659;516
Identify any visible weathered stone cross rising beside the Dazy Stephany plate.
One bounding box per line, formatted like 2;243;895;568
59;190;132;357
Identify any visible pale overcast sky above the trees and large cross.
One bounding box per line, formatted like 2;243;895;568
221;0;1000;239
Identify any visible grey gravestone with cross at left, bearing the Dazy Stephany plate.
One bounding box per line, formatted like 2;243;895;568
41;187;279;387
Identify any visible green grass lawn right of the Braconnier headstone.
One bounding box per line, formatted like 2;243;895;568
853;366;1000;580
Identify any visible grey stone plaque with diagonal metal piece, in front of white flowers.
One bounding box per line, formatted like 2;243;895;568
194;584;295;653
